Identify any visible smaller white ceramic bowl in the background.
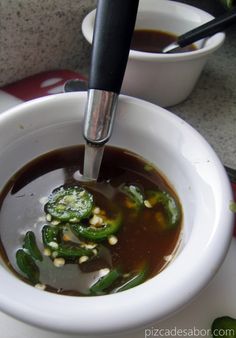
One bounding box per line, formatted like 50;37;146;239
82;0;225;107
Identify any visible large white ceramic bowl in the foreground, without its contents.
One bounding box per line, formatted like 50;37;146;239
0;93;233;335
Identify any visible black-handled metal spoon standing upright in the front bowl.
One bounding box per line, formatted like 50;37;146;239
83;0;139;180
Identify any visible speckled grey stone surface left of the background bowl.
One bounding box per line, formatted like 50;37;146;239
0;0;230;86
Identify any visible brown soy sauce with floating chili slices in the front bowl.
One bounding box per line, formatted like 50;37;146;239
0;146;182;296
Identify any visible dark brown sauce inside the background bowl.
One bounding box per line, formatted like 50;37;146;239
131;29;197;53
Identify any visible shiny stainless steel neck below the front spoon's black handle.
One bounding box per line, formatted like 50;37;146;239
84;89;118;145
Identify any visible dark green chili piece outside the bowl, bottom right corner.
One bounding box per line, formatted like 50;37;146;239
211;316;236;338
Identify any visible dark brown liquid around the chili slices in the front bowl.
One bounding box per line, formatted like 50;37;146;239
0;146;181;295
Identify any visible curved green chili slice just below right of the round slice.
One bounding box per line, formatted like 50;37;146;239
70;213;122;241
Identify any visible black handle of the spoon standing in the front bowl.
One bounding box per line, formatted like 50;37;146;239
88;0;139;93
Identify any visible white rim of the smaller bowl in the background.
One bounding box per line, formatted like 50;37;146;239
81;0;226;62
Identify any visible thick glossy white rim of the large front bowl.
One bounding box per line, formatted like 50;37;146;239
0;92;233;334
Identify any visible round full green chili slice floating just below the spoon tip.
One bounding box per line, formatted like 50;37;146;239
45;186;93;223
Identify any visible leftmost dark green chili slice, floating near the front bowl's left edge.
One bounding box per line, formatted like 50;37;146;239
16;249;40;284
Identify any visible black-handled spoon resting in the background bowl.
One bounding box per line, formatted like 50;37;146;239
162;9;236;53
